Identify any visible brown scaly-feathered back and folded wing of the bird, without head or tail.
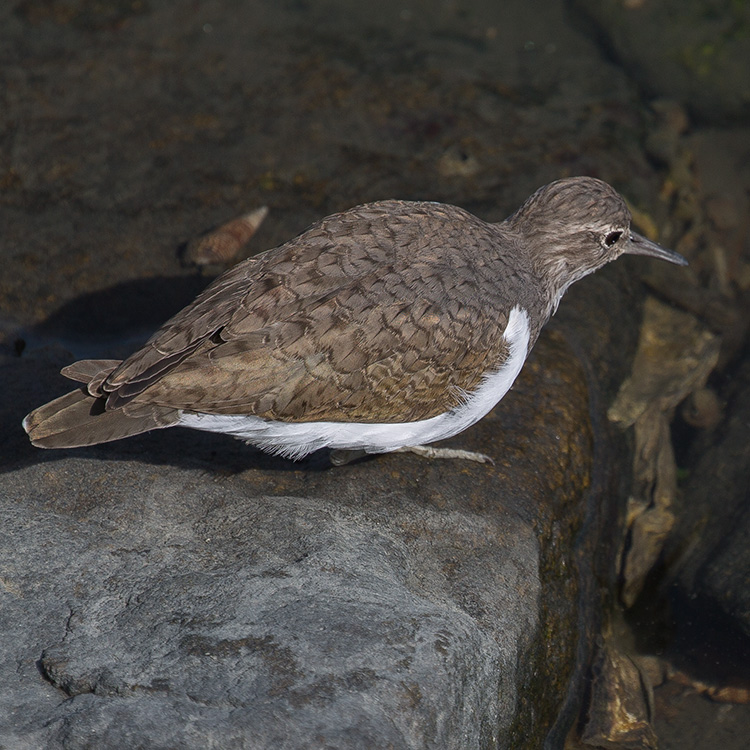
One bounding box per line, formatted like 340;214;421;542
98;202;507;422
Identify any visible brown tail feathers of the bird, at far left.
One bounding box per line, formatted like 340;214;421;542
23;360;178;448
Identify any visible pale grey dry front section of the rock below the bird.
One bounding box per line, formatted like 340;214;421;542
3;468;540;748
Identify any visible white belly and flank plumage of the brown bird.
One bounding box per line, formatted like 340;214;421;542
178;306;530;458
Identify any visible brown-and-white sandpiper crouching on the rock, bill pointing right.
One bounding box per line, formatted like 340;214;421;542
23;176;687;463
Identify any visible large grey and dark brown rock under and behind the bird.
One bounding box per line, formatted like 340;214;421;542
0;0;655;750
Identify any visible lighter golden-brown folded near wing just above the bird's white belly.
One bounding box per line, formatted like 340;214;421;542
136;272;506;422
